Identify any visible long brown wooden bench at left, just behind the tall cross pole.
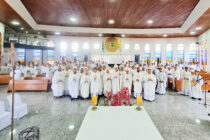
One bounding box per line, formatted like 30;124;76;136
8;80;48;92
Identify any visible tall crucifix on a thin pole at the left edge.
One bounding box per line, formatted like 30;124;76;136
2;43;16;140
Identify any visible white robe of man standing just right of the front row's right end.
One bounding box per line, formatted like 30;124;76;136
157;72;167;94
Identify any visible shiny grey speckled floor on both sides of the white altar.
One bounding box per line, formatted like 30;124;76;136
0;86;210;140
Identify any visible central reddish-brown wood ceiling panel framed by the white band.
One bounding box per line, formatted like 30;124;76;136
21;0;199;29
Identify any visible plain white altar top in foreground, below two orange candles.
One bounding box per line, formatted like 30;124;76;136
76;106;163;140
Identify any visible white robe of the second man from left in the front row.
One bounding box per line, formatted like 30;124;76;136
68;73;80;99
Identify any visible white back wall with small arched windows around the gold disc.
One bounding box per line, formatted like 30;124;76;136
48;36;198;63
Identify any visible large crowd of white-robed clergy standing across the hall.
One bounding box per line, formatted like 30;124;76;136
1;61;203;101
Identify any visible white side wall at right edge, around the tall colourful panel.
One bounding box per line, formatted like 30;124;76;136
198;29;210;72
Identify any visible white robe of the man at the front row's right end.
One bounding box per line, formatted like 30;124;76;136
144;74;156;101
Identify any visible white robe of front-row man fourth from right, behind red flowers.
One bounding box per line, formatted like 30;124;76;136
111;71;120;94
